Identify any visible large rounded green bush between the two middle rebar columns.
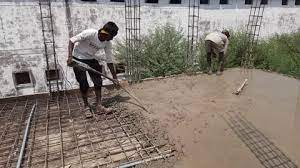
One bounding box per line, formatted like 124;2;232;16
116;24;186;78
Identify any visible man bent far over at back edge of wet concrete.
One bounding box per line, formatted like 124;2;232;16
205;30;230;75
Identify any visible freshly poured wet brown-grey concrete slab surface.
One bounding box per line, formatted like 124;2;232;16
120;69;300;168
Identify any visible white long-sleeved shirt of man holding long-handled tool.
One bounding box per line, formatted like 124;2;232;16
70;29;114;63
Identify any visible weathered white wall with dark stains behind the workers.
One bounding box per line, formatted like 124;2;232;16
0;0;300;97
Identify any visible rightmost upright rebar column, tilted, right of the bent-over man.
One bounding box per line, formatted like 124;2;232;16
241;0;266;68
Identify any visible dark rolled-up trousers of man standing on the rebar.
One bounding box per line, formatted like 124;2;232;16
73;57;102;94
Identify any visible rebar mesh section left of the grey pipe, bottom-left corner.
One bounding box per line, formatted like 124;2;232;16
0;99;35;167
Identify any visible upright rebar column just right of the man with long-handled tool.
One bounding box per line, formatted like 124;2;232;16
125;0;141;82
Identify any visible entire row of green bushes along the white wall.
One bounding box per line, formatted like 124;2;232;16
116;24;300;78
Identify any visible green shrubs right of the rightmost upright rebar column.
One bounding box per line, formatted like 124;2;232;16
255;32;300;78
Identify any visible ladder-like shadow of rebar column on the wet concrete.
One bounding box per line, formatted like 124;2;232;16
223;112;298;168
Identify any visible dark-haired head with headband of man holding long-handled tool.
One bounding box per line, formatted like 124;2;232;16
98;22;119;41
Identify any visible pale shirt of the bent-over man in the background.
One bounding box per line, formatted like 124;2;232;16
205;32;229;53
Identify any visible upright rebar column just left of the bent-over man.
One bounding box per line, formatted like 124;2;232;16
186;0;200;65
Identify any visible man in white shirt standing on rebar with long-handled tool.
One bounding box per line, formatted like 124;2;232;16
67;22;119;118
